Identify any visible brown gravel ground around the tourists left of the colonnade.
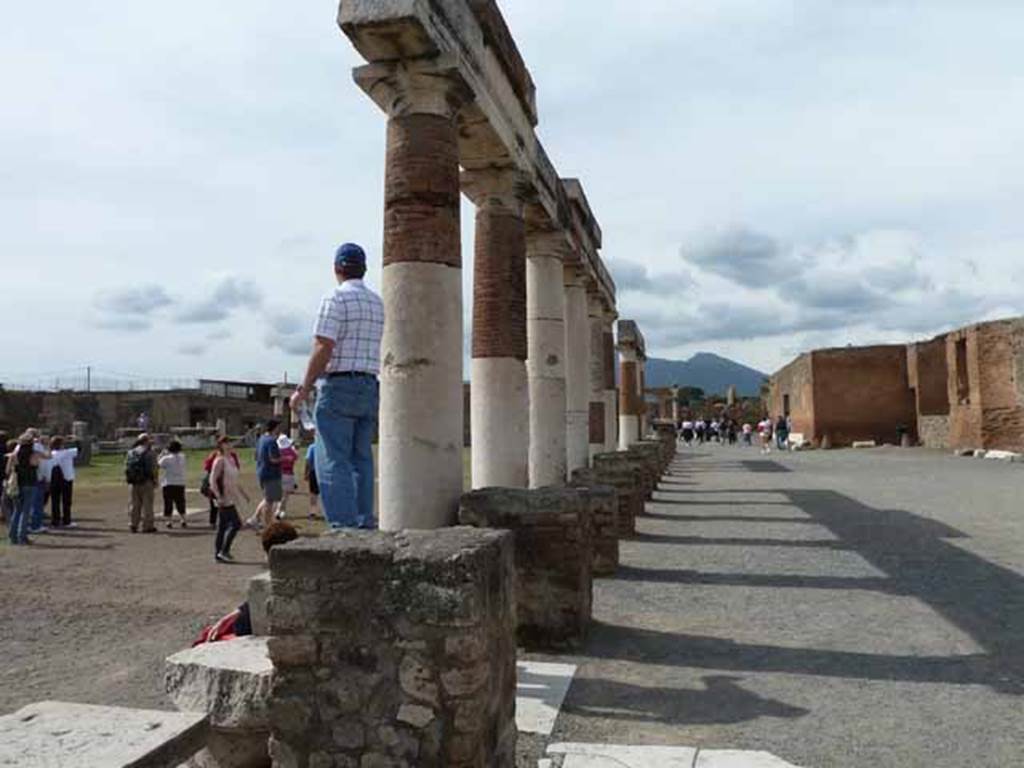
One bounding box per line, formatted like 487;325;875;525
0;484;315;713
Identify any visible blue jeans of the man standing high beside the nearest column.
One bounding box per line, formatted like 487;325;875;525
313;376;380;528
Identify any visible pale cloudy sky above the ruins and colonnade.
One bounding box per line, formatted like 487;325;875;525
0;0;1024;383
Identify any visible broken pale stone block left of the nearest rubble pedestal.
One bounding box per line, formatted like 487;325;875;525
164;637;273;768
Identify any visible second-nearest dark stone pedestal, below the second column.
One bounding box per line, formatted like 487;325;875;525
459;487;594;650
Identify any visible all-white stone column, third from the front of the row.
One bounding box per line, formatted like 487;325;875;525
526;232;568;488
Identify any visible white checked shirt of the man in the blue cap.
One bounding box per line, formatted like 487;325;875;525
313;280;384;376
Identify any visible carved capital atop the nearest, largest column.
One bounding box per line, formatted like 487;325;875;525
352;55;473;120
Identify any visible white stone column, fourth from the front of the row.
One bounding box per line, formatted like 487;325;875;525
565;266;590;474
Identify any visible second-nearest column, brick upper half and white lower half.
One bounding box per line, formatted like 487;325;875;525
463;169;529;488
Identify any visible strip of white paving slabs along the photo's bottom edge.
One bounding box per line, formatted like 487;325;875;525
538;742;799;768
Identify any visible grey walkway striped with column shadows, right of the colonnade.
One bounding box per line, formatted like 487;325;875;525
532;446;1024;768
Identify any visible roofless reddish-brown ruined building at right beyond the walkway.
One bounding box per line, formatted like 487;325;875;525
769;317;1024;451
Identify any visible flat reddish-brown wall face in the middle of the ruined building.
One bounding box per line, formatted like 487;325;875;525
811;345;918;446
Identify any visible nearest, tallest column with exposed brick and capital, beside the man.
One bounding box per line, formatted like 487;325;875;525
355;62;468;530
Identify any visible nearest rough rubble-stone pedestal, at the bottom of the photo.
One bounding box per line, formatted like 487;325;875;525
268;527;516;768
